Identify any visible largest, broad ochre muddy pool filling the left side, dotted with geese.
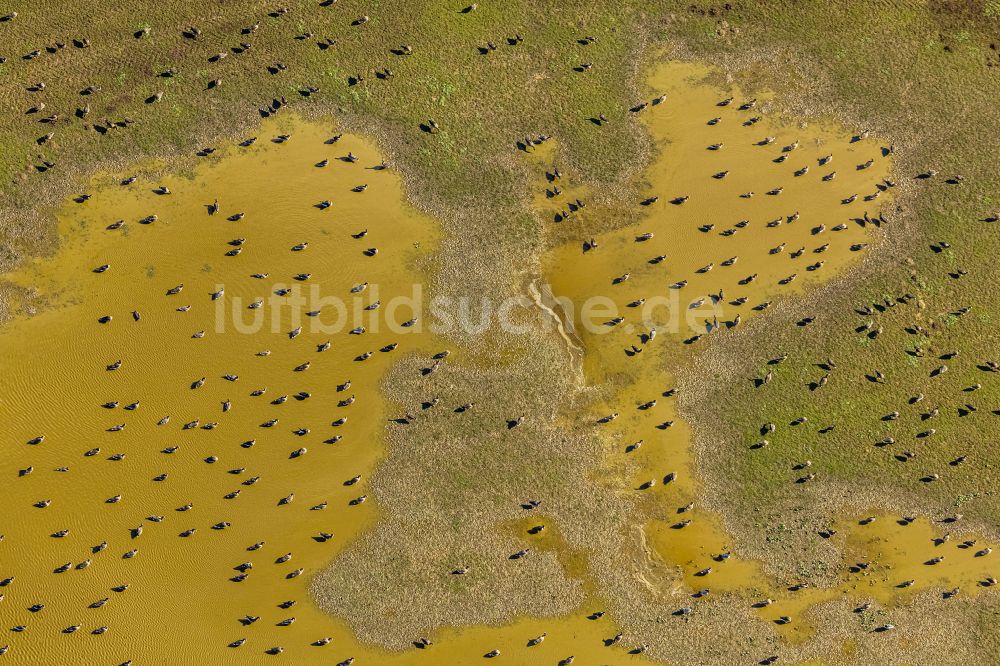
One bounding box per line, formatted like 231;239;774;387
0;120;440;664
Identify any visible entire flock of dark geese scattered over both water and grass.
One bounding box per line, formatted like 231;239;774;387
0;0;1000;666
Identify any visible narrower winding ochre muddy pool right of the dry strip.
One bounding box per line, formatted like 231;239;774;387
534;64;988;641
